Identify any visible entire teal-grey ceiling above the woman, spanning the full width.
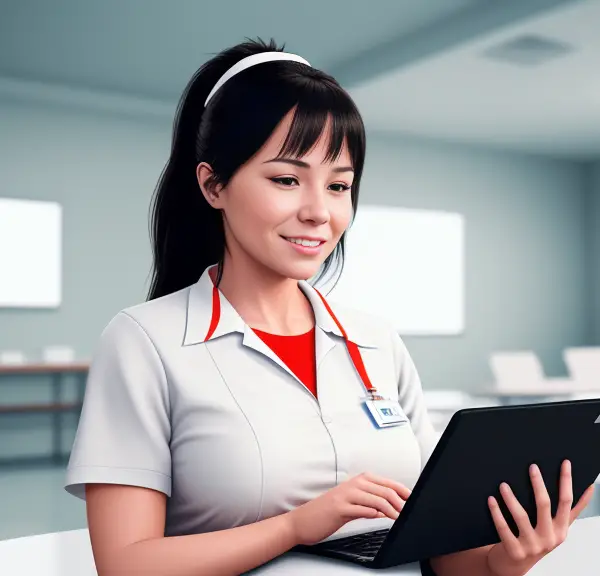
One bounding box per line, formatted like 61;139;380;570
0;0;600;158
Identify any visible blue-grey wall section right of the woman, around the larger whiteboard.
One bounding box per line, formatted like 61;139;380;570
361;135;590;390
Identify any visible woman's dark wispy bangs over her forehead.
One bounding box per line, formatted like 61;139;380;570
279;85;366;173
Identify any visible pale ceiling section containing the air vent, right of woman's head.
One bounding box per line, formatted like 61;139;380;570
352;0;600;160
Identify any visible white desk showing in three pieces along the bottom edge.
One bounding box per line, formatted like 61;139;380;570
0;517;600;576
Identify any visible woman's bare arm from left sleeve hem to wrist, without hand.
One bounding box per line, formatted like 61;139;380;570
86;484;296;576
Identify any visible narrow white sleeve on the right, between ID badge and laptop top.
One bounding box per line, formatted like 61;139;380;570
392;331;439;466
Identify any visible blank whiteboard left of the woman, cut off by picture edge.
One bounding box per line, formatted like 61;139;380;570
0;198;62;308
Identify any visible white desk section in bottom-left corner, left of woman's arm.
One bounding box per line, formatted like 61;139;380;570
0;529;98;576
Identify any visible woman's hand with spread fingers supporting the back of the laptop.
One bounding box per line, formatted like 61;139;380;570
487;460;594;576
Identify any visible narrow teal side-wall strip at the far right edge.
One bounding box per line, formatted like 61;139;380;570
587;162;600;346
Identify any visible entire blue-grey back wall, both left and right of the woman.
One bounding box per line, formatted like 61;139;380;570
0;99;589;457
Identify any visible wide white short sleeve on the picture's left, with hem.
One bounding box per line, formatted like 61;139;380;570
65;312;171;499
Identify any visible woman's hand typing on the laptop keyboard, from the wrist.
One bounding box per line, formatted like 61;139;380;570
288;472;411;545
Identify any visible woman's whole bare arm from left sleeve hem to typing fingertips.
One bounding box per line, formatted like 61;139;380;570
86;473;410;576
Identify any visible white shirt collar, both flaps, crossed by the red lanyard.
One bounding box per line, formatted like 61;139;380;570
183;266;377;348
